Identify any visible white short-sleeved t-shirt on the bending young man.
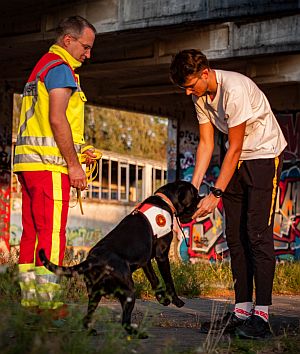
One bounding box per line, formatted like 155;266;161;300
192;70;287;160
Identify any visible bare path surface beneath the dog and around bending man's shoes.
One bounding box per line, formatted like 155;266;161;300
89;296;300;354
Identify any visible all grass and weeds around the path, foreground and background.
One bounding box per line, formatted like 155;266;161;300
0;254;300;354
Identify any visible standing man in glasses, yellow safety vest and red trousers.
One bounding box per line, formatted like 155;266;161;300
14;16;96;318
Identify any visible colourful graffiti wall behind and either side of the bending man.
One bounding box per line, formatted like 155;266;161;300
178;112;300;262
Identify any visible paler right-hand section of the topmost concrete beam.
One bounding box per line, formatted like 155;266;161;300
118;0;300;30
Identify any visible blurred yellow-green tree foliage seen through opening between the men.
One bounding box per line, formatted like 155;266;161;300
85;106;167;161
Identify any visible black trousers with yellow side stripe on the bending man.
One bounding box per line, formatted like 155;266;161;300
223;154;283;306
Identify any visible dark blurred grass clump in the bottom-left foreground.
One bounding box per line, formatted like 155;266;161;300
0;301;139;354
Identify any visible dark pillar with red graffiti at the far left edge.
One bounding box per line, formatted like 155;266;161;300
0;81;13;265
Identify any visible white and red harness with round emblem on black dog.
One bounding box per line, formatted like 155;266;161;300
135;203;173;238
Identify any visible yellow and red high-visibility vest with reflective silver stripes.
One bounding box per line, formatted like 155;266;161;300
13;44;86;173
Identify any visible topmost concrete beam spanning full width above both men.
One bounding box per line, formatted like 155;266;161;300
0;0;300;36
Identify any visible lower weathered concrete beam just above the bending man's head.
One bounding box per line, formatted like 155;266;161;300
159;15;300;60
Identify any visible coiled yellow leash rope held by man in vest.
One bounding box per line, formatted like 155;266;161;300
75;145;102;215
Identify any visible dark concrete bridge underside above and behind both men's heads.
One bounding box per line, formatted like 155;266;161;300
0;0;300;119
